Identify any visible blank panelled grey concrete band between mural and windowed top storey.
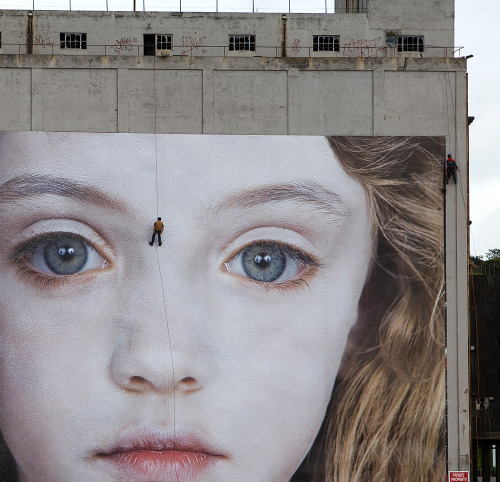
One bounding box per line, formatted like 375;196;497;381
0;55;465;137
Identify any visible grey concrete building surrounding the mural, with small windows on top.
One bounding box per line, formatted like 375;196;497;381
0;0;470;470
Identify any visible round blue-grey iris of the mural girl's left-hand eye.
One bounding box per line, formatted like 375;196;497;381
43;236;88;275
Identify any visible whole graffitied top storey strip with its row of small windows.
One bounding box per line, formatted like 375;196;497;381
0;10;459;58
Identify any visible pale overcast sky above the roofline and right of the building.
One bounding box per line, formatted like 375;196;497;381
0;0;500;255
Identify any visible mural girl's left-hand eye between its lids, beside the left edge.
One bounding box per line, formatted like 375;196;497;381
14;233;107;276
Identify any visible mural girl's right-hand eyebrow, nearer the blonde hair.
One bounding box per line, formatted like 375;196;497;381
215;182;350;217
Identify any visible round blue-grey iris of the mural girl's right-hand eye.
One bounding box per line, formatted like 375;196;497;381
241;243;286;283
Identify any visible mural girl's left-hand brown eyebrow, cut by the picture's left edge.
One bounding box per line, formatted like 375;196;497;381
0;174;127;212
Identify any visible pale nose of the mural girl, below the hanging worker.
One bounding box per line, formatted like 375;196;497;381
111;268;210;394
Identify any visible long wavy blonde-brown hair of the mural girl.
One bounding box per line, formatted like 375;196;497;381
325;137;446;482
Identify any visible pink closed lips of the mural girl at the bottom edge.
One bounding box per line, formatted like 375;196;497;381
94;432;228;482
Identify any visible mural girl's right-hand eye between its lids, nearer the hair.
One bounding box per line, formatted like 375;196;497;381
224;241;321;283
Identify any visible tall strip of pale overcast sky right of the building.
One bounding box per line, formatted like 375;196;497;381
455;0;500;255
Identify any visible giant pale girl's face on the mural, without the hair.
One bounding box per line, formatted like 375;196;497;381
0;133;373;482
